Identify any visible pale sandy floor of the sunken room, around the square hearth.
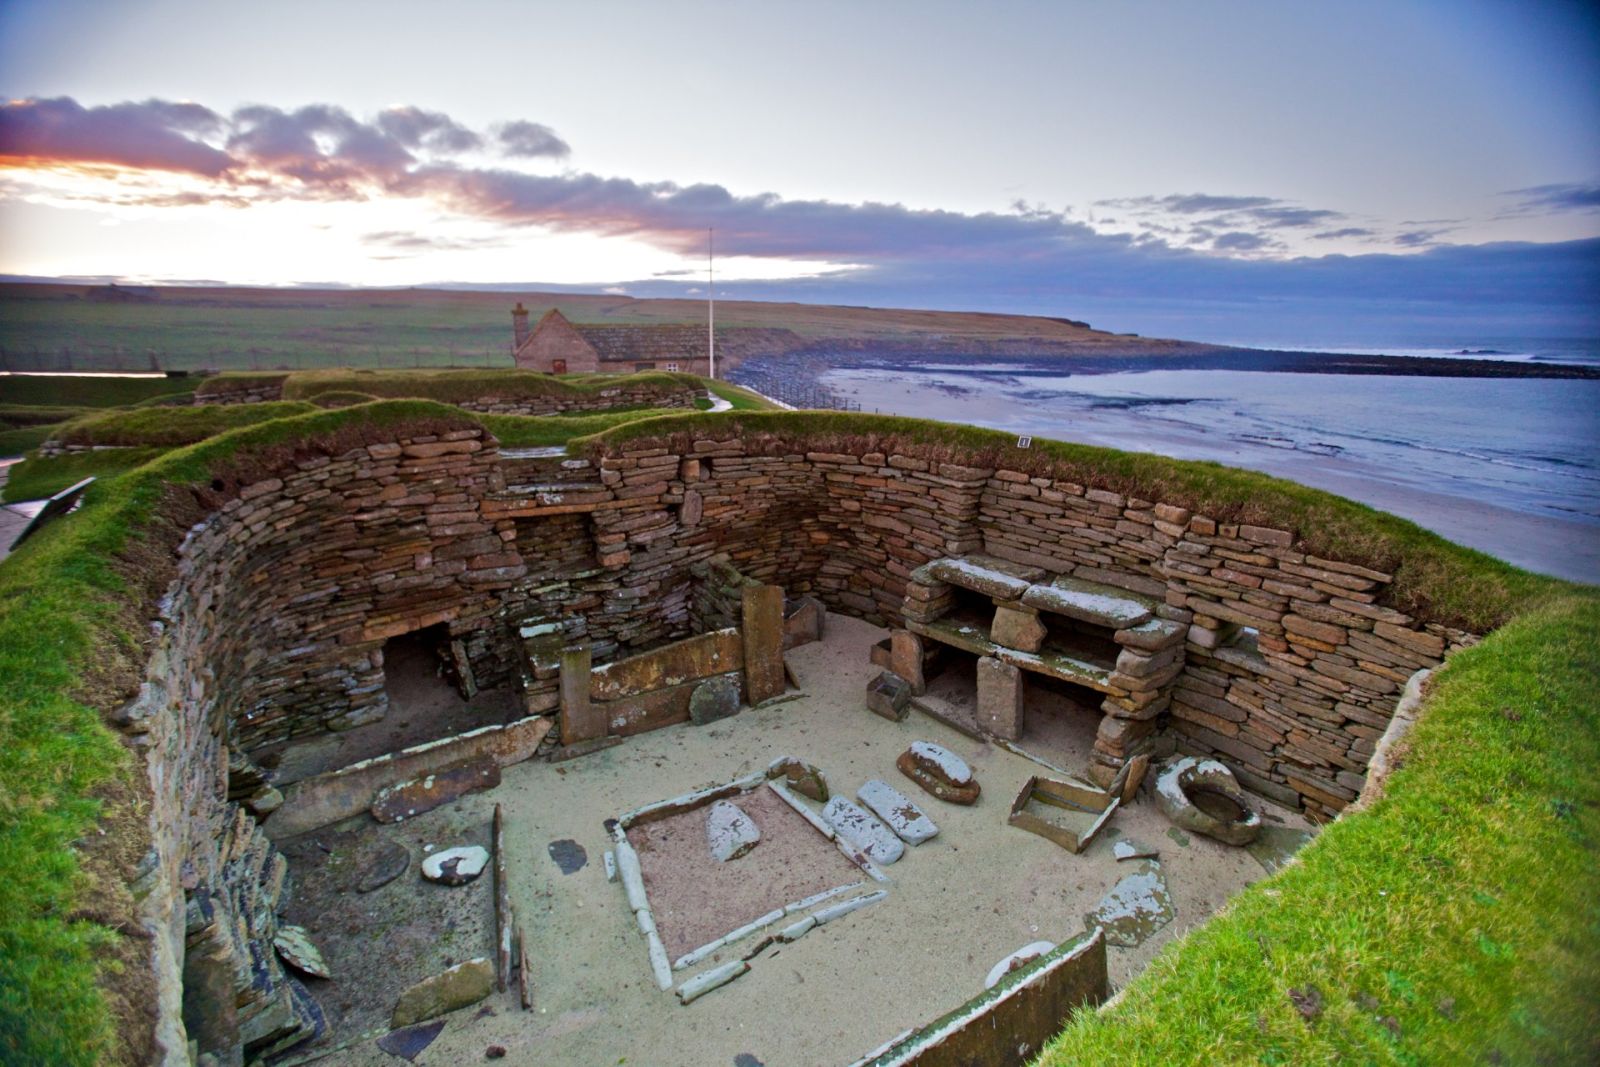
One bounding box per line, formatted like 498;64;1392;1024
302;617;1304;1067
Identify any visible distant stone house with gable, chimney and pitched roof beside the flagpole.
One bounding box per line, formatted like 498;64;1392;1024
510;302;710;376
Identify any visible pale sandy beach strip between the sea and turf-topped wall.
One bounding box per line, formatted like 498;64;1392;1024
822;371;1600;584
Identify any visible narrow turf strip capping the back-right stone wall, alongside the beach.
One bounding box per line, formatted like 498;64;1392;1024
571;411;1571;633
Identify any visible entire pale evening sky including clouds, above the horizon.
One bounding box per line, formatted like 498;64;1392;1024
0;0;1600;344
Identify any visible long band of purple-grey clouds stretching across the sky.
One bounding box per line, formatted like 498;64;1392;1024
0;98;1600;336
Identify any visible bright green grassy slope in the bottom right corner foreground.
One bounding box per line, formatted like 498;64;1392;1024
1038;590;1600;1067
